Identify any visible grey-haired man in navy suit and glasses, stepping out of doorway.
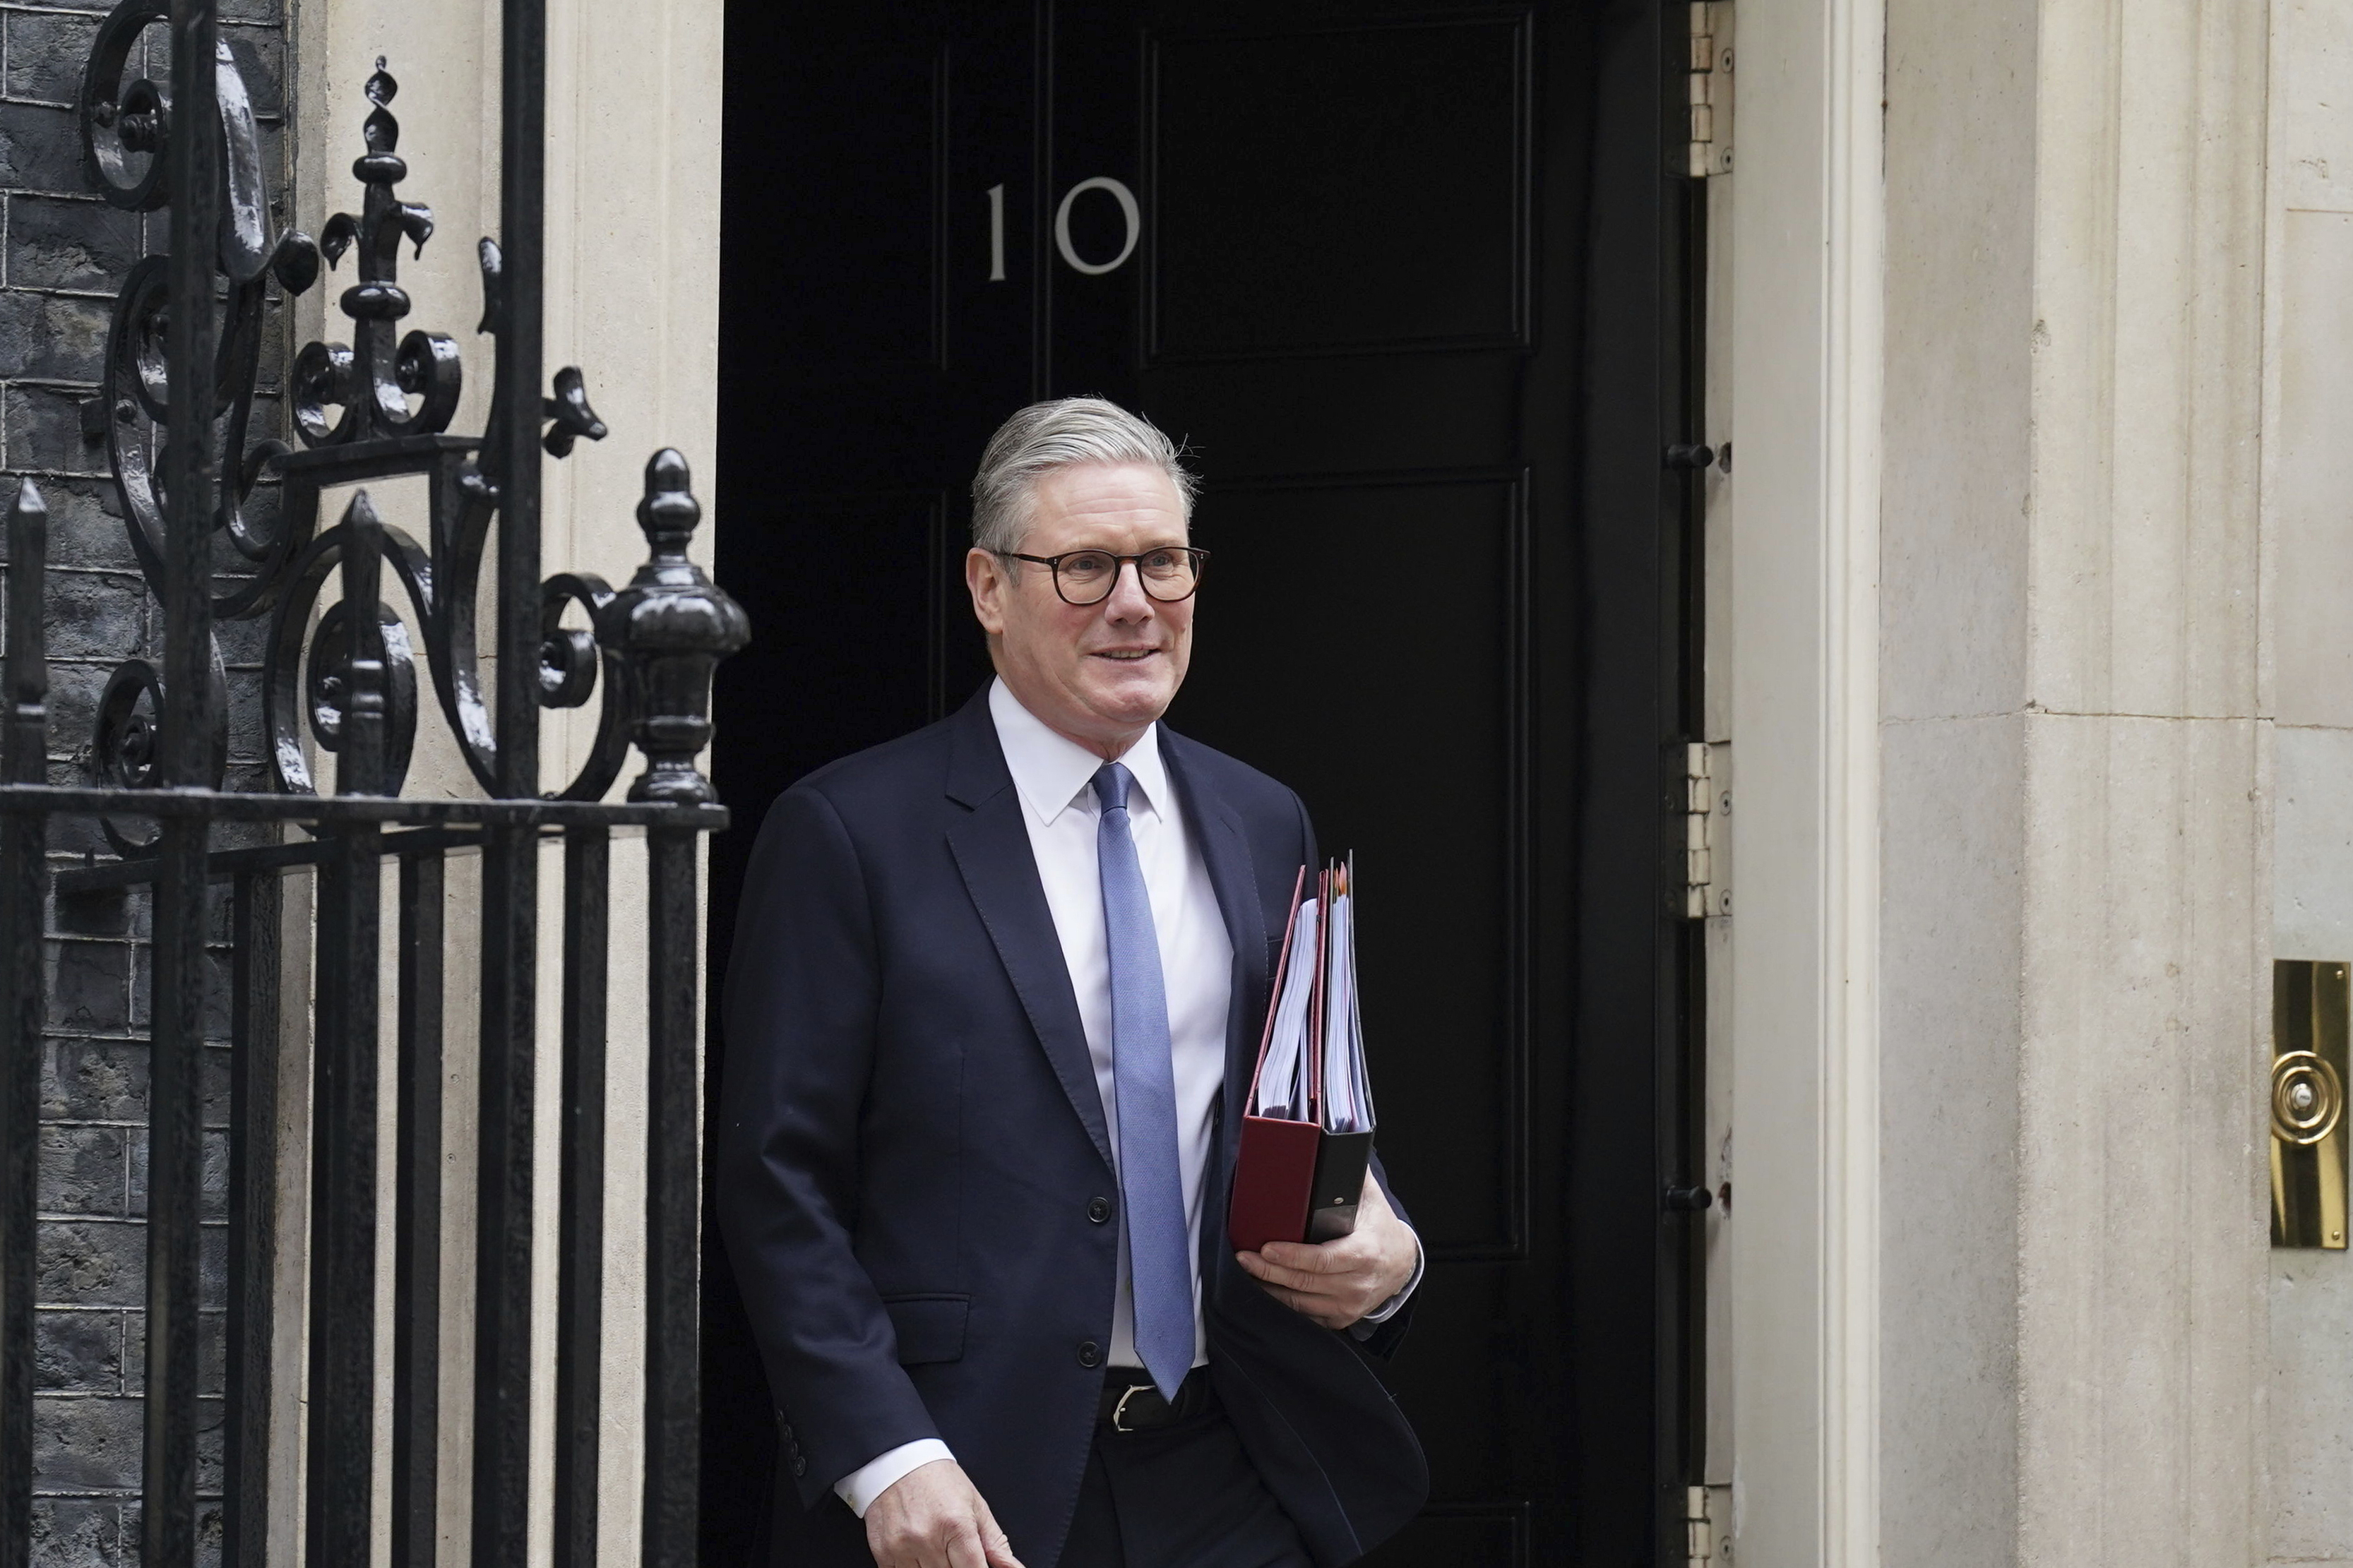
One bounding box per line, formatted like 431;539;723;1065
717;400;1429;1568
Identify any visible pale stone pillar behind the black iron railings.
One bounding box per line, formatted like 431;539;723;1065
273;0;722;1568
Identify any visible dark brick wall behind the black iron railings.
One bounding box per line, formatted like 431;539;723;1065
0;0;290;1568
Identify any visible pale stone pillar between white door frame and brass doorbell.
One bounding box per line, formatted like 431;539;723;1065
1863;0;2270;1568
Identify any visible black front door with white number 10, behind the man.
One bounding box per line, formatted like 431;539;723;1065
706;0;1696;1568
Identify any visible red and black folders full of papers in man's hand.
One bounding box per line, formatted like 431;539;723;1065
1226;861;1374;1253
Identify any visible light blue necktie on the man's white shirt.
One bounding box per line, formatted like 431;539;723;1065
1094;762;1193;1401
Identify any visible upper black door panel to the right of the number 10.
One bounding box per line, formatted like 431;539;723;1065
1146;16;1527;364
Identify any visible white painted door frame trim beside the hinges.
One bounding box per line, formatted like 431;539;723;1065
1710;0;1885;1568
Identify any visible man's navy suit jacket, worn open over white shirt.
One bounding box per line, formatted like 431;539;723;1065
717;691;1429;1568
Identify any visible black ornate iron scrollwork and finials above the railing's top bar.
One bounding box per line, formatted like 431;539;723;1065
83;12;741;818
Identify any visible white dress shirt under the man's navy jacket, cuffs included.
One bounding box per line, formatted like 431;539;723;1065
833;682;1422;1519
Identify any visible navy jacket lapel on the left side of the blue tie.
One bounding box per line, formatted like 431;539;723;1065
948;686;1111;1168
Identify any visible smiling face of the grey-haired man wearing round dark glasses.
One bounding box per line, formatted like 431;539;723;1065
965;463;1193;757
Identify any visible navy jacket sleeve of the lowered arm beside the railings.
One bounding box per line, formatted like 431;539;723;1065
715;787;939;1504
